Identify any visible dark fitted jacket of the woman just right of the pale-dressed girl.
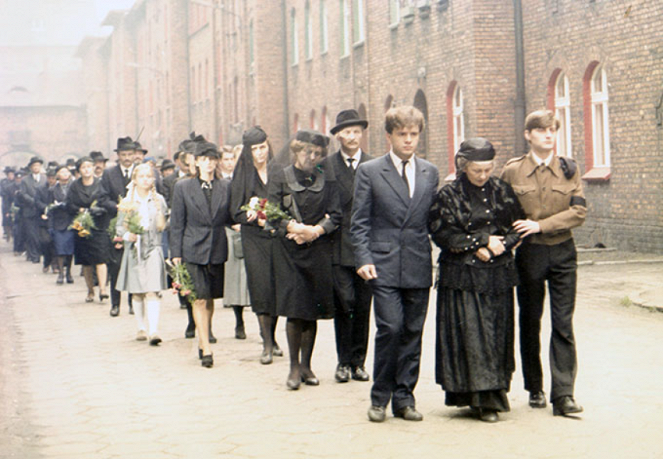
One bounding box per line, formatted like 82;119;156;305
170;178;232;265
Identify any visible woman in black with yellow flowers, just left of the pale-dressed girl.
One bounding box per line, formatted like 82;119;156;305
65;156;111;303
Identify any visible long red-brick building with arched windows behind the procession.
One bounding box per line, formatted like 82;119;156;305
76;0;663;252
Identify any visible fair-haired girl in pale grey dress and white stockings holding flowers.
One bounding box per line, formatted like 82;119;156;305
115;164;168;346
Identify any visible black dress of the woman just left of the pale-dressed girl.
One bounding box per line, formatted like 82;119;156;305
65;177;111;266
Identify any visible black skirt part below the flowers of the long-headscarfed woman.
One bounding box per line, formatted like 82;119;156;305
242;225;276;316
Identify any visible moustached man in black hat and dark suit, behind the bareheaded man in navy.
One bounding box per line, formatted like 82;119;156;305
325;109;373;383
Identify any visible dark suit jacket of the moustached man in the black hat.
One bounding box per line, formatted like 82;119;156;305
324;151;373;267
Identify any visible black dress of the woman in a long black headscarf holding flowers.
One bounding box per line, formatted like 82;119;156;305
230;167;276;316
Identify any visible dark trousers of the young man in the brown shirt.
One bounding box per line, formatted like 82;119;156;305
516;239;577;400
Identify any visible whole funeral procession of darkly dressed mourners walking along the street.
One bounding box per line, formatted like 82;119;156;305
1;106;586;422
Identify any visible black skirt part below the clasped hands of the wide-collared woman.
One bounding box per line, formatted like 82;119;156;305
274;236;334;320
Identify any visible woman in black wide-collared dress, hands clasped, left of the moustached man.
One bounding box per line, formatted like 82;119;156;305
269;130;341;390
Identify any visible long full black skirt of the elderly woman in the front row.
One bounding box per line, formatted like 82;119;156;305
435;288;515;411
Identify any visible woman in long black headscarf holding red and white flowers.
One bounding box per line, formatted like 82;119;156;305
230;126;283;365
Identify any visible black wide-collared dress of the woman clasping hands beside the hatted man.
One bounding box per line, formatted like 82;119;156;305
269;166;341;320
